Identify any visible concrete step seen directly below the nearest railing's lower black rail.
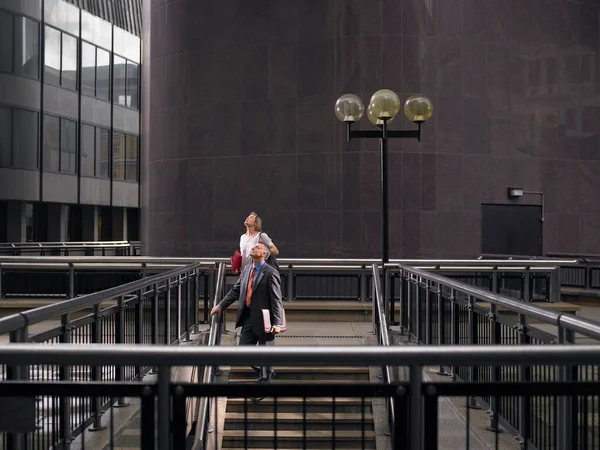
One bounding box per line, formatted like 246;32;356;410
227;397;372;415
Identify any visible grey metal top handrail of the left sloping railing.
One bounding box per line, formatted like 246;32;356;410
0;262;205;334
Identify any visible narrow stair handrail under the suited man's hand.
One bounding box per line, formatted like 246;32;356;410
192;263;226;450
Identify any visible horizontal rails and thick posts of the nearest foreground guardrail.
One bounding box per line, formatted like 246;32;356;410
0;344;600;450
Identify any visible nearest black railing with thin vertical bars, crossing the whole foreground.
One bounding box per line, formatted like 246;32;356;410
0;344;600;450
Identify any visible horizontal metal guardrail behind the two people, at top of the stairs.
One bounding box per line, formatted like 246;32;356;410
0;257;577;302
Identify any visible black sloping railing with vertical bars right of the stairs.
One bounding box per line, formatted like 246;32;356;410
386;266;600;449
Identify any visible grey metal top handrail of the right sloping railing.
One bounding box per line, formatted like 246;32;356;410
399;265;600;340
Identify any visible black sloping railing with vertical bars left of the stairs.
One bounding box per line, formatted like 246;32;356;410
0;263;210;448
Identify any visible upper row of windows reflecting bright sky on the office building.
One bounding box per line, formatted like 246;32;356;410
0;11;139;109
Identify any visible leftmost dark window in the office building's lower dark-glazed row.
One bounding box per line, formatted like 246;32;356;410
0;105;39;169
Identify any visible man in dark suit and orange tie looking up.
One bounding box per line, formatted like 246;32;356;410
210;242;283;392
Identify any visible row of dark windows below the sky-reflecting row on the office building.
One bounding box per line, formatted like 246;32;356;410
0;105;139;181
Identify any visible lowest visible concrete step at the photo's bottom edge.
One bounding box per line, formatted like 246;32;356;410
223;430;375;449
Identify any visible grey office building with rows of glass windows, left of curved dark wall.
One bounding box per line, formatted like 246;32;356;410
0;0;141;242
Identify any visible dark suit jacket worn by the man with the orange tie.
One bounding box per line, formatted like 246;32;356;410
219;262;283;339
